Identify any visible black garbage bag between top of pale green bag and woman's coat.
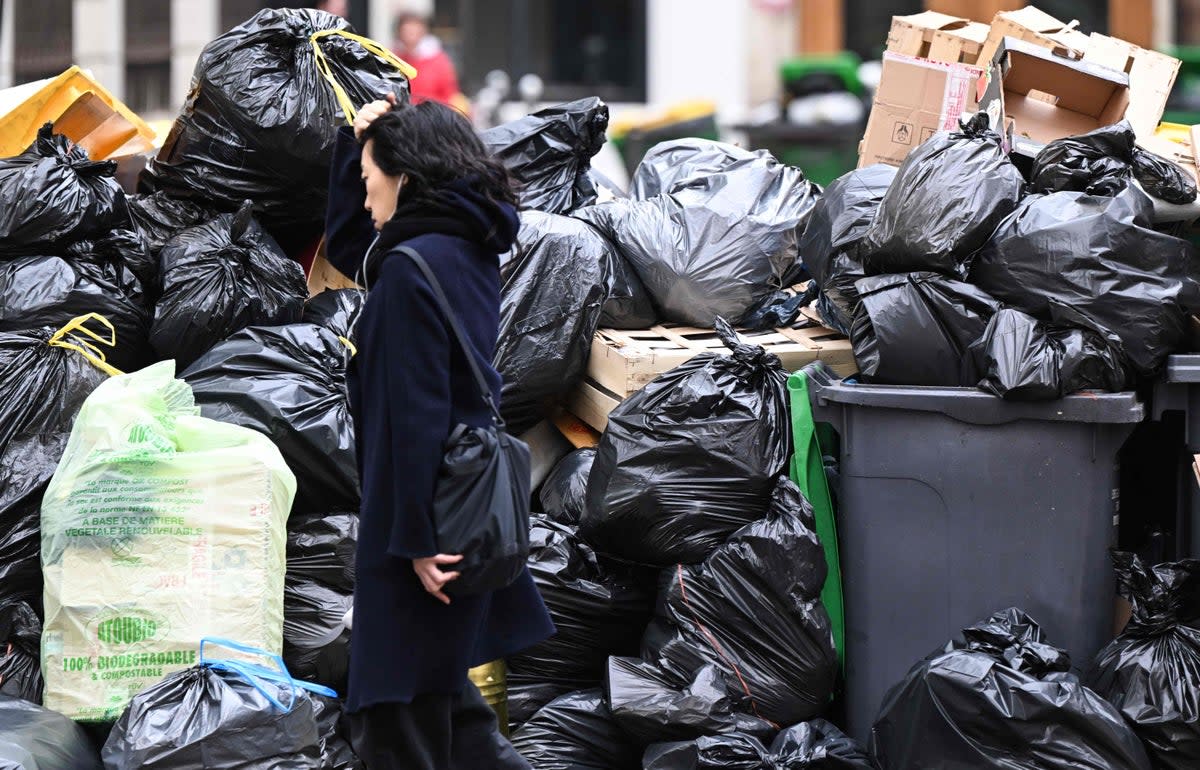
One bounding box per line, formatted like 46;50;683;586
179;316;359;513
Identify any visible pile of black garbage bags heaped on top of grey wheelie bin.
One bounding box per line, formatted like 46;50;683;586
800;114;1200;401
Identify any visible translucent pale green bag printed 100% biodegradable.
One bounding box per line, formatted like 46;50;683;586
42;361;296;721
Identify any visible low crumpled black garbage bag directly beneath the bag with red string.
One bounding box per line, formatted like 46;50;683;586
605;657;776;746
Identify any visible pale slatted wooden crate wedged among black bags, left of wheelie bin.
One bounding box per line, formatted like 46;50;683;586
566;325;857;431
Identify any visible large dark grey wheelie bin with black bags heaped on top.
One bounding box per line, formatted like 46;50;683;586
805;365;1142;739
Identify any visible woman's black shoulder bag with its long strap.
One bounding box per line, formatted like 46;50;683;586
400;247;530;596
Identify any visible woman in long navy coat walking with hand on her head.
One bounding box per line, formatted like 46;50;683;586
326;97;553;770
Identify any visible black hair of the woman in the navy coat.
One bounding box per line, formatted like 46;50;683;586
360;102;517;213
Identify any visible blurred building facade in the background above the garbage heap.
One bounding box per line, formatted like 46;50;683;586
0;0;1200;124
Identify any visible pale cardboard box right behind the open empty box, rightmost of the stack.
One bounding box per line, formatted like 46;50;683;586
1084;34;1181;140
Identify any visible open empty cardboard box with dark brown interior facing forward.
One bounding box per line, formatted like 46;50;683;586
979;37;1129;154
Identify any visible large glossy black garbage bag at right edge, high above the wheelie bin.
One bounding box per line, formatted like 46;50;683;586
971;187;1200;375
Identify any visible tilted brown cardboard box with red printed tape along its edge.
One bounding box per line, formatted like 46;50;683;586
858;52;984;168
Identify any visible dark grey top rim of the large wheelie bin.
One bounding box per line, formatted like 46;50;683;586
805;368;1145;425
